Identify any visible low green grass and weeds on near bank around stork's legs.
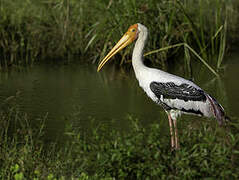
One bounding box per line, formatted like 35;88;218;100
0;98;239;180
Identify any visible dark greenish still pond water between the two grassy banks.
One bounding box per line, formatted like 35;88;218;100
0;53;239;141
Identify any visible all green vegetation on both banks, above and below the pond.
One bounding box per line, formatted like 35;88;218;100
0;0;239;180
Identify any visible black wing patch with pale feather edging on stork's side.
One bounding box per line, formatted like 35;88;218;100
150;82;207;102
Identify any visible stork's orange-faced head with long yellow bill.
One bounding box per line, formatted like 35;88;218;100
97;23;147;71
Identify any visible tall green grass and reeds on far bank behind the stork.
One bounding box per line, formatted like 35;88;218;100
0;0;239;69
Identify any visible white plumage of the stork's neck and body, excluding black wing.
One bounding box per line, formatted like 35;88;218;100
132;23;223;121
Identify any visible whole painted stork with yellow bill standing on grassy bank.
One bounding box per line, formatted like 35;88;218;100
97;23;225;149
